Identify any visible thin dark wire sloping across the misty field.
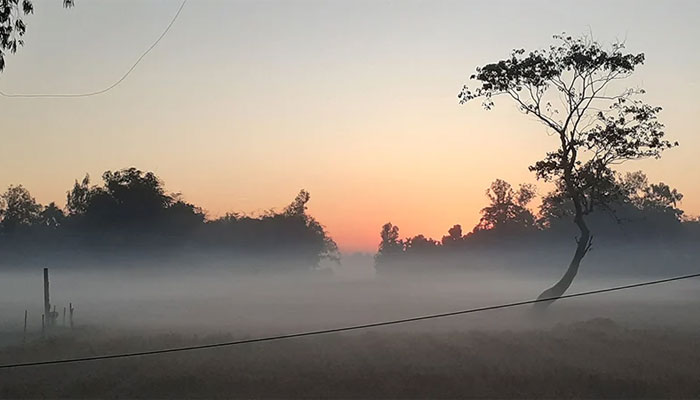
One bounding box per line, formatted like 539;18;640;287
0;273;700;369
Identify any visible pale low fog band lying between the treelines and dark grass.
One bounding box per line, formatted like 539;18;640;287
0;255;700;337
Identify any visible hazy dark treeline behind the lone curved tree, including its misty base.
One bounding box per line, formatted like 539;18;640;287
375;172;700;273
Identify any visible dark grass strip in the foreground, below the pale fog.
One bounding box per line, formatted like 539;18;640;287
0;319;700;398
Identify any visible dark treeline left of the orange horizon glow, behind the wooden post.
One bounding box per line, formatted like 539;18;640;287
0;168;339;271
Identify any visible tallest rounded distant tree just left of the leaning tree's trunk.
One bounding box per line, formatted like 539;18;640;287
474;179;537;231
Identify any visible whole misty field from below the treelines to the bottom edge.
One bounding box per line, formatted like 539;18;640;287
0;271;700;398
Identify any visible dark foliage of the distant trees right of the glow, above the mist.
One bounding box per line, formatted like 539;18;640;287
375;177;700;273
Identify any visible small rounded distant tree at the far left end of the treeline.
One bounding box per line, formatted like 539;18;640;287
0;185;42;233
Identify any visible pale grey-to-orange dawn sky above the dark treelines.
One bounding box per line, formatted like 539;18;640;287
0;0;700;252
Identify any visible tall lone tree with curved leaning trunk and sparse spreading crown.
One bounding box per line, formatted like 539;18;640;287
459;34;677;306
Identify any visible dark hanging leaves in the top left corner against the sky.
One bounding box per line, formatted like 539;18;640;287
0;0;74;72
